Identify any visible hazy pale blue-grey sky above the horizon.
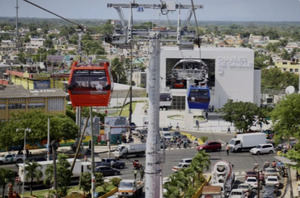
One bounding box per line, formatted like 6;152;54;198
0;0;300;21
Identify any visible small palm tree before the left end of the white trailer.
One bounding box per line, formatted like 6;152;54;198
25;162;43;195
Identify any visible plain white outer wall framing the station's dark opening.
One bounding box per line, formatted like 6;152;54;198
160;47;260;108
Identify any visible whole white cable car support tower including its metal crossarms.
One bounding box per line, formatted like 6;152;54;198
105;1;202;198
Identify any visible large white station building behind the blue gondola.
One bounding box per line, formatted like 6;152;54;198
160;47;261;109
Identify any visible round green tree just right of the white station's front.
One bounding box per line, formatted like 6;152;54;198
221;100;267;132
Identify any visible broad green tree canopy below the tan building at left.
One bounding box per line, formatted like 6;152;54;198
0;111;78;149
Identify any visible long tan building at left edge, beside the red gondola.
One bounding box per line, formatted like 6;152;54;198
0;85;66;121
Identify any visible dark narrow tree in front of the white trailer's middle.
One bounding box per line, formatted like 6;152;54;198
44;154;72;197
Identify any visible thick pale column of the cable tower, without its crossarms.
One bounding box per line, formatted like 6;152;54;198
145;33;161;198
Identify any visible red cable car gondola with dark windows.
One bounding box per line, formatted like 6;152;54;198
68;62;112;107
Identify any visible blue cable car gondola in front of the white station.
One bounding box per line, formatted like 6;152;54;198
187;85;210;109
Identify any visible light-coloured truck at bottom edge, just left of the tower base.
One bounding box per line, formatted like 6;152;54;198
117;179;144;198
